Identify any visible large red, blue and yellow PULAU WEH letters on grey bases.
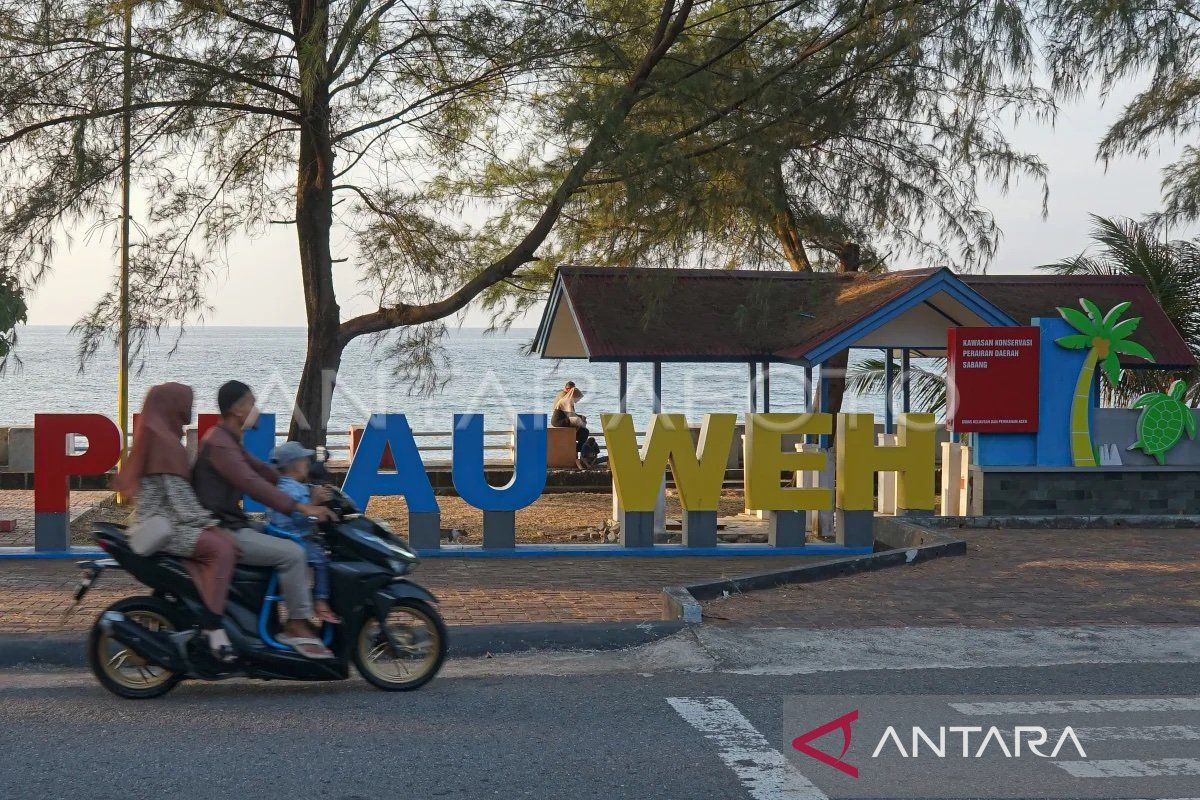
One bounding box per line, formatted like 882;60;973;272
25;414;936;551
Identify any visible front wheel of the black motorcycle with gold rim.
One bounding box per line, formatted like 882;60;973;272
353;599;446;692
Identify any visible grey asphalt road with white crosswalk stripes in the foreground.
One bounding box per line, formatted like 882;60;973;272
0;663;1200;800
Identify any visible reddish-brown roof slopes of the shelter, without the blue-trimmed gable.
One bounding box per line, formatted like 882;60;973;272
542;266;1195;367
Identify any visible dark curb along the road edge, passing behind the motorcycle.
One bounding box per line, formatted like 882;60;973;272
0;620;684;669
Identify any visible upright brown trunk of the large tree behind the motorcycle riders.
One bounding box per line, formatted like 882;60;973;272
288;0;344;447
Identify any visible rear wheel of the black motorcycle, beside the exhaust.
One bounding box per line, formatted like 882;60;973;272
88;597;184;700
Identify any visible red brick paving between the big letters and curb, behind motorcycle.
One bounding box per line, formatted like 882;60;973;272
0;557;816;633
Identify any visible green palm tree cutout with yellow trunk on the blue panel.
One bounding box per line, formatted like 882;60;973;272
1055;299;1154;467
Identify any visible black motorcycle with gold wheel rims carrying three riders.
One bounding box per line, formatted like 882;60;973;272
74;487;446;699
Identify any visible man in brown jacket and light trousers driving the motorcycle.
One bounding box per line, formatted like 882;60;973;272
192;380;335;658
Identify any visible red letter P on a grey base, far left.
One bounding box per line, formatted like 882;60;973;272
34;414;121;551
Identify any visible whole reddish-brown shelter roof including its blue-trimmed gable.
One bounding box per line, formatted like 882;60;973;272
534;266;1195;368
